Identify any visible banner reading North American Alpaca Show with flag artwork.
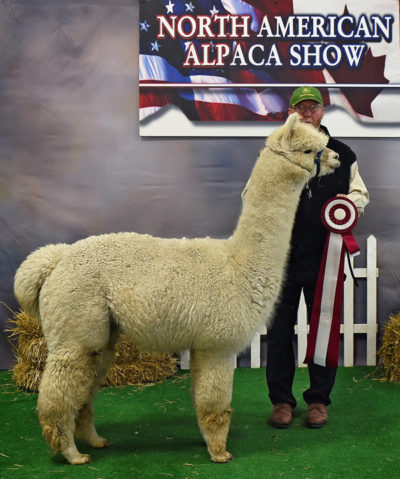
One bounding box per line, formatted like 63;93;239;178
139;0;400;136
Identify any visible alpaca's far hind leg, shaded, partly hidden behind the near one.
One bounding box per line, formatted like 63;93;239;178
75;344;114;448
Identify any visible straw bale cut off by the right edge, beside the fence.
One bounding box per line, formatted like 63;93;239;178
378;312;400;383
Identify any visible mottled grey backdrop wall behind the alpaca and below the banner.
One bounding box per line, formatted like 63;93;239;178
0;0;400;369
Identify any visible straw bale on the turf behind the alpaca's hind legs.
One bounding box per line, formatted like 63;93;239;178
7;311;177;392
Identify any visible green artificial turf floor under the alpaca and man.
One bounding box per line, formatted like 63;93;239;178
0;367;400;479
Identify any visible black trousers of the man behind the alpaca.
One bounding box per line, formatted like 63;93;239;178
266;272;336;407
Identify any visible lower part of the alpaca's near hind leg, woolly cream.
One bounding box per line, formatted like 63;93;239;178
38;349;96;464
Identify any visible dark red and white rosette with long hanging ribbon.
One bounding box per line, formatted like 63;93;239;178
304;196;360;368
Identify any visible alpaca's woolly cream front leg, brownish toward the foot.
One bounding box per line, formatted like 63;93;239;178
191;351;234;462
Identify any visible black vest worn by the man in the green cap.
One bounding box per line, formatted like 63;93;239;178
288;125;356;279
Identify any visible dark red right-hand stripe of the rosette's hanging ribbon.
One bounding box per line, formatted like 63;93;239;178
326;244;345;368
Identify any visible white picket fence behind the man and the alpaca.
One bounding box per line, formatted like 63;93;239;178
180;235;379;369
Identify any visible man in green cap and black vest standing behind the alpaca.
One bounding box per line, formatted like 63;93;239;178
266;86;369;428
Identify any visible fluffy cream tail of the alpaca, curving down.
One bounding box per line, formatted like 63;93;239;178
14;243;68;319
